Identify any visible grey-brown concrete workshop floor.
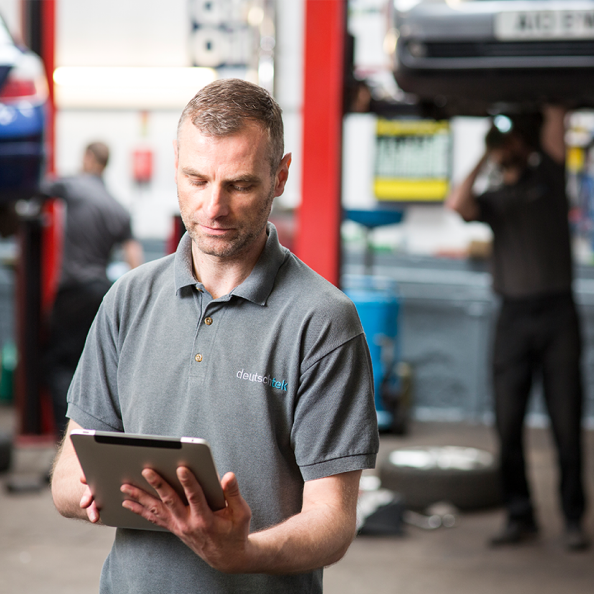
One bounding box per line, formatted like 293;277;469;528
0;407;594;594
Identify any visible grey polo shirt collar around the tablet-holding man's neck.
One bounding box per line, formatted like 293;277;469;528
174;222;289;305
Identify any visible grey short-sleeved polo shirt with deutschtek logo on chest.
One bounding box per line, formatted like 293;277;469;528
68;224;378;594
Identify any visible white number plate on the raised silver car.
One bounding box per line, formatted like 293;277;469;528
494;9;594;41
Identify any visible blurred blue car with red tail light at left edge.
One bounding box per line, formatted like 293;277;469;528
0;17;48;205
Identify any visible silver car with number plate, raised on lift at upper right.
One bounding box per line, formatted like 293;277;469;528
390;0;594;117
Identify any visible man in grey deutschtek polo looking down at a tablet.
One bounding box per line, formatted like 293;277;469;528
52;79;378;594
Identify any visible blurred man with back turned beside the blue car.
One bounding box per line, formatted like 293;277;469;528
42;142;142;437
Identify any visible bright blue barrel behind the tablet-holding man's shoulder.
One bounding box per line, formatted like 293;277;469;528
342;275;400;429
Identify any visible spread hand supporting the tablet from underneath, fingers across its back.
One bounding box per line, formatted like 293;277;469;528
121;467;252;573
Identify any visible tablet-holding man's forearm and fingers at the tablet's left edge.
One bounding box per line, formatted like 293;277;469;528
51;420;99;523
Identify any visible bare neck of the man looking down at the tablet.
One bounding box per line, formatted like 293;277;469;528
192;236;266;299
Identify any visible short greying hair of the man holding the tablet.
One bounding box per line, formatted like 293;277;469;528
177;78;285;175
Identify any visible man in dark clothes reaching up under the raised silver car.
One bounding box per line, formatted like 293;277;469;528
448;106;588;550
